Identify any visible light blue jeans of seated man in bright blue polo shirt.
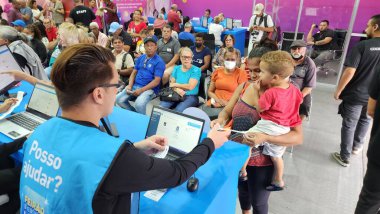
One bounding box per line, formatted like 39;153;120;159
116;86;154;114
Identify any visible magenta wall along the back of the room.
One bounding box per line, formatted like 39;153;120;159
173;0;380;33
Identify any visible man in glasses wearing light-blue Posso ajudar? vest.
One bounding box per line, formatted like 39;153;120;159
20;44;230;214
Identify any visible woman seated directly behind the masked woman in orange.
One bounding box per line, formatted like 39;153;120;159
212;34;241;70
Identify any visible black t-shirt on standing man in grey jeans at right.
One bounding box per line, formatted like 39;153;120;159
340;38;380;105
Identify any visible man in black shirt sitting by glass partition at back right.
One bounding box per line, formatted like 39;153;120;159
307;20;335;66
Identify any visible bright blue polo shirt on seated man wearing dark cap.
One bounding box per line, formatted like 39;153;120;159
133;54;165;93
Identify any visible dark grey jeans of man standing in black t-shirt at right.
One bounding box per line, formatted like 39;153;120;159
338;101;371;160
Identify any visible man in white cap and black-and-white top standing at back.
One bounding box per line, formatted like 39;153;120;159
248;3;274;53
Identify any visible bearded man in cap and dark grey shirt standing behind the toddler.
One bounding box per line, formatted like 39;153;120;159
290;40;317;119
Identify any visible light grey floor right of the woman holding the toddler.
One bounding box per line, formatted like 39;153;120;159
236;84;367;214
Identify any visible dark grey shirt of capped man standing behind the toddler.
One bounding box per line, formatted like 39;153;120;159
290;56;317;90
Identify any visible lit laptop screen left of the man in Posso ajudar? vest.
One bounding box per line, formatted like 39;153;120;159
28;83;59;117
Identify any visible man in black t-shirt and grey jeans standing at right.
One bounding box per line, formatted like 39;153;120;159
332;14;380;166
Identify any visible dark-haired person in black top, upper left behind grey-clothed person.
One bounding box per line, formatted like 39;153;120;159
23;24;47;63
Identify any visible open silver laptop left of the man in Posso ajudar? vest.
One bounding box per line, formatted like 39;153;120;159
0;83;59;139
